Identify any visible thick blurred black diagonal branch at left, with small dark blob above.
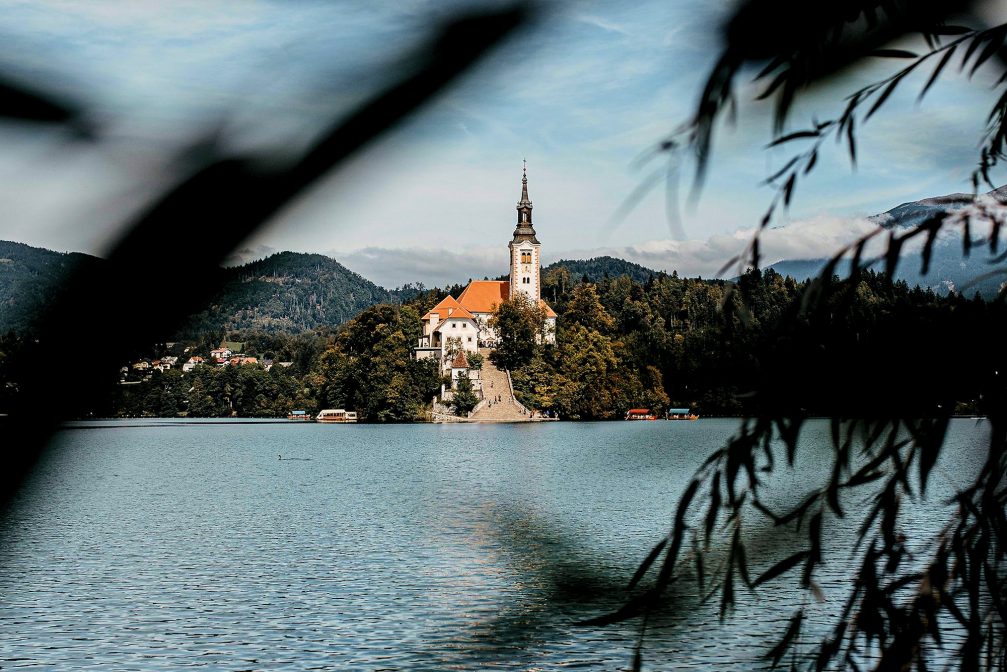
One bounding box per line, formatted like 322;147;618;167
0;4;530;494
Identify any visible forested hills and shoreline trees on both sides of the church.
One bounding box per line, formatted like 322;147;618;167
0;237;1007;421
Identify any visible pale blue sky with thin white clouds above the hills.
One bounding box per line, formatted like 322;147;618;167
0;0;1003;287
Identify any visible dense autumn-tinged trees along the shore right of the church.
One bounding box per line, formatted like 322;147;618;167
513;270;994;418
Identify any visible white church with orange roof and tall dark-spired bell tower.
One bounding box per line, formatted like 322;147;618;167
416;165;556;369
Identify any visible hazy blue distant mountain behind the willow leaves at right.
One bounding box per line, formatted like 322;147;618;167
770;186;1007;298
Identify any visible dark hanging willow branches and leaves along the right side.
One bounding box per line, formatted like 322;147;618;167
588;0;1007;671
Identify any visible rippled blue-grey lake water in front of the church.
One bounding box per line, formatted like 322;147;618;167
0;419;987;670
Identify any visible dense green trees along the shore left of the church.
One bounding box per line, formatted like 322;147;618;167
104;304;441;422
